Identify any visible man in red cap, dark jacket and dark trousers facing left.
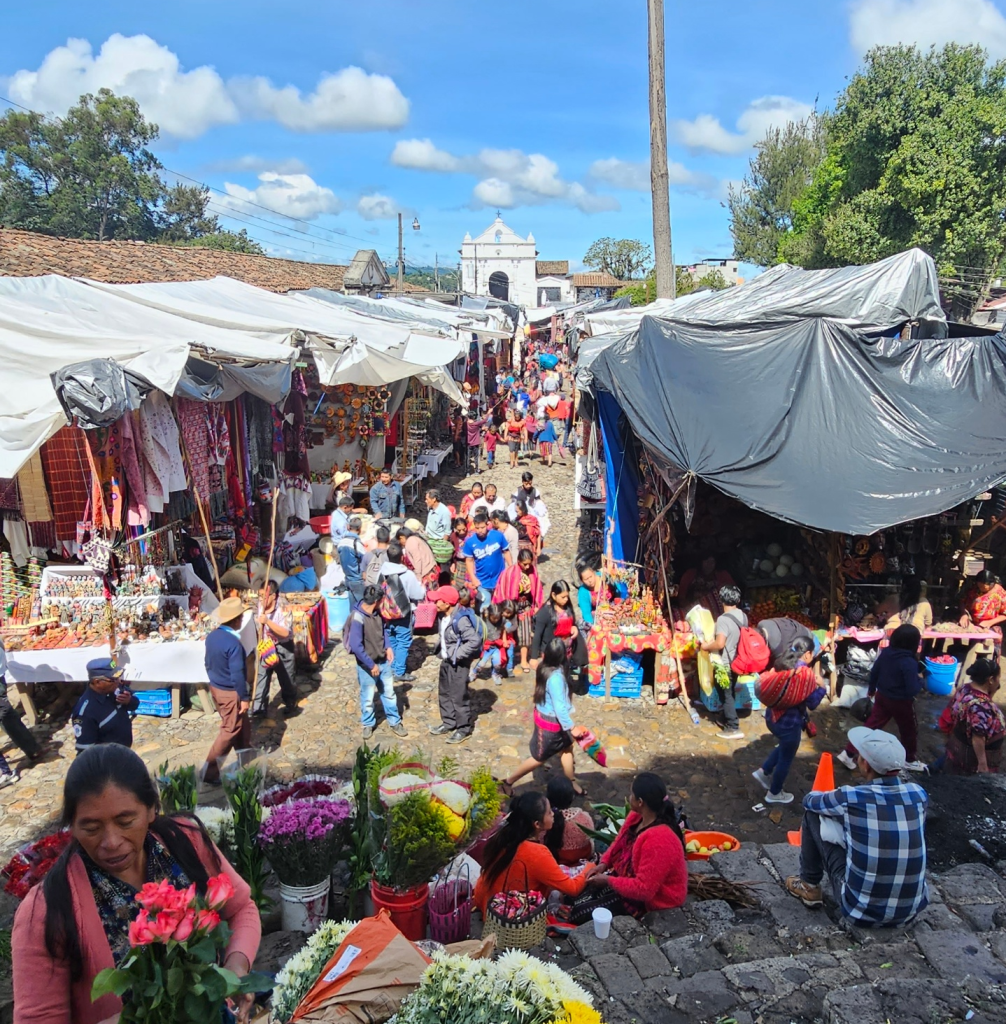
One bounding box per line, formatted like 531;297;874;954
426;587;484;743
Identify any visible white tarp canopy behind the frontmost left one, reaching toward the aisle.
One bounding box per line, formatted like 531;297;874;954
88;278;464;402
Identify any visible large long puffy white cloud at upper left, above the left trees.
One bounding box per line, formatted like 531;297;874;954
0;33;409;138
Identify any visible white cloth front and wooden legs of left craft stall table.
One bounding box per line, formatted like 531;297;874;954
7;611;257;725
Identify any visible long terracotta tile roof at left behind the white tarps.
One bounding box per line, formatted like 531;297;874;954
0;228;350;292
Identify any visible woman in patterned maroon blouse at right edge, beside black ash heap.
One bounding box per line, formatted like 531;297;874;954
947;657;1006;775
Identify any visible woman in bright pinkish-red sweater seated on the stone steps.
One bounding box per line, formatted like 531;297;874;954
569;771;688;925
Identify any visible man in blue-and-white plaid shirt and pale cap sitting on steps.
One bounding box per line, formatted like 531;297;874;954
786;727;929;927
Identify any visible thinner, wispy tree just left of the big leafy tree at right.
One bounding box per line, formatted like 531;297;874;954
724;114;825;266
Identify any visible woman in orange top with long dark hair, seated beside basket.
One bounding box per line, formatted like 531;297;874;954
473;793;597;916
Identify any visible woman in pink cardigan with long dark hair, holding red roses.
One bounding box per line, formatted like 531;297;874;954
11;743;262;1024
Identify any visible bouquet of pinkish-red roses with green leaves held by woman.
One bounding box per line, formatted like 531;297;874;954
91;874;271;1024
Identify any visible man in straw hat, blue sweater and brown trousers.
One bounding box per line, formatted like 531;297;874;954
200;597;251;785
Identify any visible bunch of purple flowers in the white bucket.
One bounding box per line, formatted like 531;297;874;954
258;799;352;886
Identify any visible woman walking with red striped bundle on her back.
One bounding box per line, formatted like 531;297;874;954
752;636;827;804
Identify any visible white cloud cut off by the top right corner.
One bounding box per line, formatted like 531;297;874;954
849;0;1006;58
